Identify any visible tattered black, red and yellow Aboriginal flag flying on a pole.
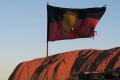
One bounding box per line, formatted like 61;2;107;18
47;5;106;41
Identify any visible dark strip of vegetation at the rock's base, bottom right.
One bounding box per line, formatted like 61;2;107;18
70;71;120;80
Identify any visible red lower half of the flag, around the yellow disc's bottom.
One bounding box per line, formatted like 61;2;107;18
48;18;99;41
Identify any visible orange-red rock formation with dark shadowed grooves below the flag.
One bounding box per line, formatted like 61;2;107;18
9;48;120;80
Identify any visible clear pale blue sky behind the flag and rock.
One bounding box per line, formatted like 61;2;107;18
0;0;120;80
